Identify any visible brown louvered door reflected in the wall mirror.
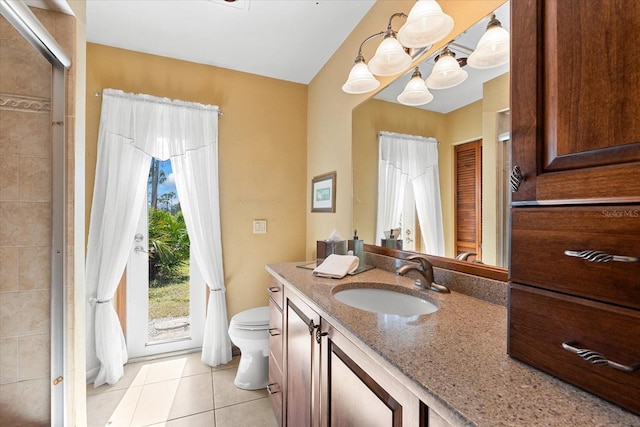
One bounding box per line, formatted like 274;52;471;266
454;140;482;261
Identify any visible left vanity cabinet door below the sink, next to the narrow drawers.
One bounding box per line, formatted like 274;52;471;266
285;296;320;427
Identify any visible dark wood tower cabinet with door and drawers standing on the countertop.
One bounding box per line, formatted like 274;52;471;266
507;0;640;414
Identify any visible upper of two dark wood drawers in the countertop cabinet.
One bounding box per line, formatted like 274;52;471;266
509;205;640;308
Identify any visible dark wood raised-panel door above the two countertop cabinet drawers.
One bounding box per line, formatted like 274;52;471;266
511;0;640;205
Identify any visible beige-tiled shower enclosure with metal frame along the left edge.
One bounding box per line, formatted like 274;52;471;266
0;0;75;426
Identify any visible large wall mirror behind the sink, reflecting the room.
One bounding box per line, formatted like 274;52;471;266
352;2;510;278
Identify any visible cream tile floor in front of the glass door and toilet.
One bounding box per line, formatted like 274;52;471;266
87;353;276;427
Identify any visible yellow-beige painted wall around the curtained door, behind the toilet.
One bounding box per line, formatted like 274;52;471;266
86;43;308;317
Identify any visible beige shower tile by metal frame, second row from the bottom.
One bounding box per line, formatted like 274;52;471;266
18;333;51;381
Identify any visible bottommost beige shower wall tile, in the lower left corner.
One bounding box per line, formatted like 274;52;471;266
0;378;51;426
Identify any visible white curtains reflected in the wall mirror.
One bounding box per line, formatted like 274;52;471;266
376;132;444;256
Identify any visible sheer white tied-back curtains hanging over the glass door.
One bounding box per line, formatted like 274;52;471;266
87;89;231;387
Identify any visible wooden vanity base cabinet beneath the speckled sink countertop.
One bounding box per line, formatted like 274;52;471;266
269;276;449;427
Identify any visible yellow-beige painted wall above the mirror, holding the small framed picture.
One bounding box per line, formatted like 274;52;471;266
306;0;505;259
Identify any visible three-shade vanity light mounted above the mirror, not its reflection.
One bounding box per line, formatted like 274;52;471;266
342;0;453;94
